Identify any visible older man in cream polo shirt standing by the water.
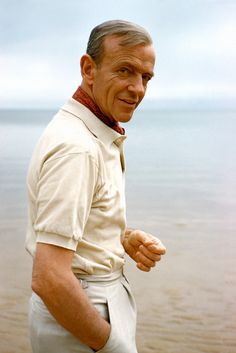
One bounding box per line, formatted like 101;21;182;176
26;21;165;353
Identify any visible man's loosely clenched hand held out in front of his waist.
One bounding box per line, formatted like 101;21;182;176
122;229;166;272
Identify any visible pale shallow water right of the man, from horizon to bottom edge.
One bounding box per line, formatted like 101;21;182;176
123;112;236;353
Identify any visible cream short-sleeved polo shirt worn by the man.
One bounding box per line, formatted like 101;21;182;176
26;99;126;274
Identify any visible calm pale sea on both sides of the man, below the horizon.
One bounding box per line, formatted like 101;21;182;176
0;108;236;353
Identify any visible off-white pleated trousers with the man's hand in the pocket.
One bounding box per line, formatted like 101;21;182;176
29;272;138;353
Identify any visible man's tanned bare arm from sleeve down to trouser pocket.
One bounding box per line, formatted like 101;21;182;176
32;243;110;350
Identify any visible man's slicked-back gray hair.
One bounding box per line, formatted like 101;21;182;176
86;20;152;64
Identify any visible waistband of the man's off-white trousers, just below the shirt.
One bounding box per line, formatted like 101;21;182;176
74;269;123;287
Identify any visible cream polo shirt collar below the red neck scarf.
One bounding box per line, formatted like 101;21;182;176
62;98;127;147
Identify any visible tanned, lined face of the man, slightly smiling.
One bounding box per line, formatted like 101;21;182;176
92;36;155;122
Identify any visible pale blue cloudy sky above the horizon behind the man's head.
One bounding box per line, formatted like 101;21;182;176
0;0;236;108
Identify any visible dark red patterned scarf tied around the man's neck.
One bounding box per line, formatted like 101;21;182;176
72;86;125;135
